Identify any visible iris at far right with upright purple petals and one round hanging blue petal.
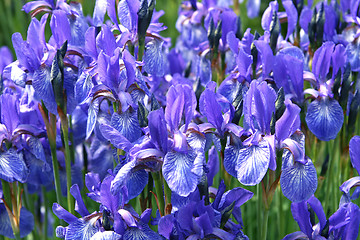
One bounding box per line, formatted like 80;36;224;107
305;42;346;141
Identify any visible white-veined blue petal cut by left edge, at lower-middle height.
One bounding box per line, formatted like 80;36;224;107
0;148;28;183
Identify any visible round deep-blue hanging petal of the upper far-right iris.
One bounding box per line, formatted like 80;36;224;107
305;98;344;141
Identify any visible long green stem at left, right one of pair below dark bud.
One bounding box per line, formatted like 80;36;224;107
59;114;75;214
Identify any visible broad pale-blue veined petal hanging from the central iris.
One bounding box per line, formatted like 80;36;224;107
162;150;204;197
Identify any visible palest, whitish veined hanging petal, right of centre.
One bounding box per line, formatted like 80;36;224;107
235;140;270;185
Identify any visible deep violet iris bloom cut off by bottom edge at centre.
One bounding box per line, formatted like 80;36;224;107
158;182;253;239
